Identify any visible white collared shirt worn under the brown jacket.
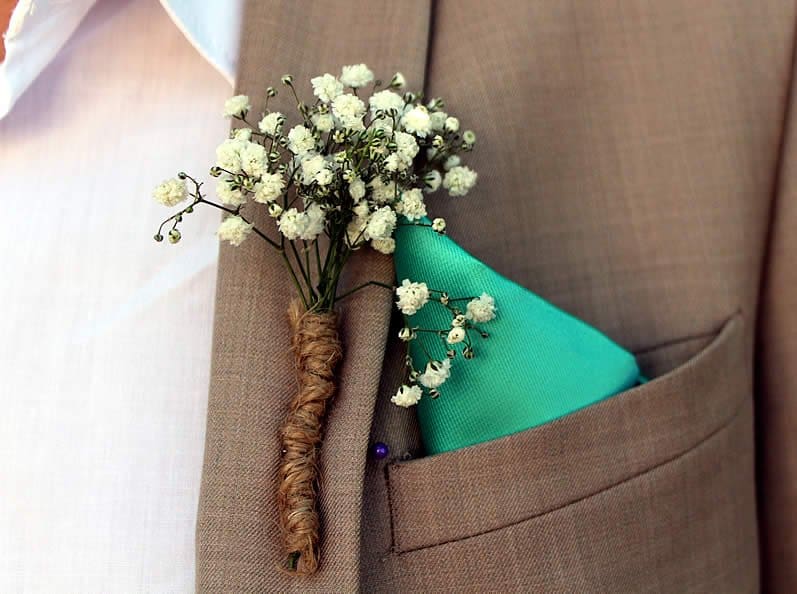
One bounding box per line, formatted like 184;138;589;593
0;0;239;594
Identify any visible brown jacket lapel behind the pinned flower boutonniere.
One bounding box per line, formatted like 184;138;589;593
196;0;431;592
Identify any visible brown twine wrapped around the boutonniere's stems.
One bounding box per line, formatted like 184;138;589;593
277;300;343;575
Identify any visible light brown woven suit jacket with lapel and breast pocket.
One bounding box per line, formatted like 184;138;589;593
197;0;797;593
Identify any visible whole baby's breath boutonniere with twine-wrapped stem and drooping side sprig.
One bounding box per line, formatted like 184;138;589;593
154;64;495;574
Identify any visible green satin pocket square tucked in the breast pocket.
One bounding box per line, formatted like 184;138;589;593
395;220;644;455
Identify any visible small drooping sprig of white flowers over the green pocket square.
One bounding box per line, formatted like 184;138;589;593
391;279;496;407
